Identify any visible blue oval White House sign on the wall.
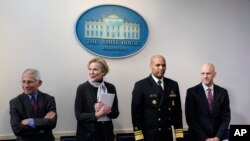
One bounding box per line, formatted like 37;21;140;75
76;5;148;58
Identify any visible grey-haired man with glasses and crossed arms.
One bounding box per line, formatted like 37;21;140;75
10;69;57;141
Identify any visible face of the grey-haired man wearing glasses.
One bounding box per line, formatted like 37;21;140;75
21;74;42;94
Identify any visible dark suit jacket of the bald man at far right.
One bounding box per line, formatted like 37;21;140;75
185;83;231;141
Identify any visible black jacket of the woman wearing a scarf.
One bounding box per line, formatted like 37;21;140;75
75;81;119;141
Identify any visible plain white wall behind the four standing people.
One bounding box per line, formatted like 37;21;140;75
0;0;250;135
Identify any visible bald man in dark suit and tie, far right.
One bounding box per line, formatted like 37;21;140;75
185;63;231;141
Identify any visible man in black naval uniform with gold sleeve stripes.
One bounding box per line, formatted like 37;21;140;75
131;55;183;141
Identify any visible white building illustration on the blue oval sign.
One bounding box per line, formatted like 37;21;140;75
84;14;140;40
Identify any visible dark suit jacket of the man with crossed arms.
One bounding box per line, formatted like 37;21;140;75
10;91;57;141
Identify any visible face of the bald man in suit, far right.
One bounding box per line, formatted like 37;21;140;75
201;64;216;87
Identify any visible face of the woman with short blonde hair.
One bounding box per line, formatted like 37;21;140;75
89;62;105;81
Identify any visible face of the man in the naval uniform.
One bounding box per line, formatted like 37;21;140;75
150;56;166;79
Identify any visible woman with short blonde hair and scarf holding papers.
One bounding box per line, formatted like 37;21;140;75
75;58;119;141
